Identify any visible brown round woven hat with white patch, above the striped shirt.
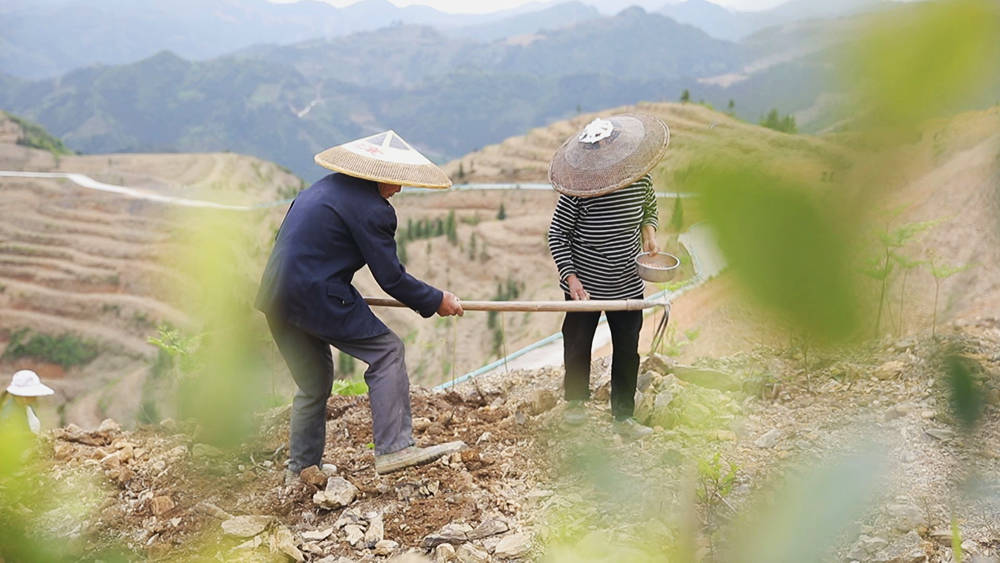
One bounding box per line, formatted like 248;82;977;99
549;113;670;197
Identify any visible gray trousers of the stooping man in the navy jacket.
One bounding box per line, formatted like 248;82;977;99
267;317;413;472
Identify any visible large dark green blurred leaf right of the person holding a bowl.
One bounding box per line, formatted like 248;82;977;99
689;165;859;341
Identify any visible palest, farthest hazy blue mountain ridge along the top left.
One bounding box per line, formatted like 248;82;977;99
0;0;563;78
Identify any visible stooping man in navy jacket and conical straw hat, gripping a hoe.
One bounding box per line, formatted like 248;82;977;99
257;131;464;476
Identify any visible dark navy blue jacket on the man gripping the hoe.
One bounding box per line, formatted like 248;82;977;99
256;174;443;340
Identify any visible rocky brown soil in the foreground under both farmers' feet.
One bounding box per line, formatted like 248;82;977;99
7;319;1000;562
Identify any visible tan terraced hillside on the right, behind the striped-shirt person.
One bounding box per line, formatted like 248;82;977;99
446;103;1000;359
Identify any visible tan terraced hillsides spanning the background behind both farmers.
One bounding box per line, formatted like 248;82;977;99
0;104;1000;432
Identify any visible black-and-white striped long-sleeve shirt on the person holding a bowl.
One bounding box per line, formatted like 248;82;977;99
549;174;657;299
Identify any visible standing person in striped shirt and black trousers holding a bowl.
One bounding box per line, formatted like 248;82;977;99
548;114;670;438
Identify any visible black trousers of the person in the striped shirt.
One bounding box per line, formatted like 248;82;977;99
562;296;642;420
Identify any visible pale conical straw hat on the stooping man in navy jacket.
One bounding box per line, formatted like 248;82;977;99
315;131;451;189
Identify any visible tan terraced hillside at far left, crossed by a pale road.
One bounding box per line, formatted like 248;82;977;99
0;114;300;425
